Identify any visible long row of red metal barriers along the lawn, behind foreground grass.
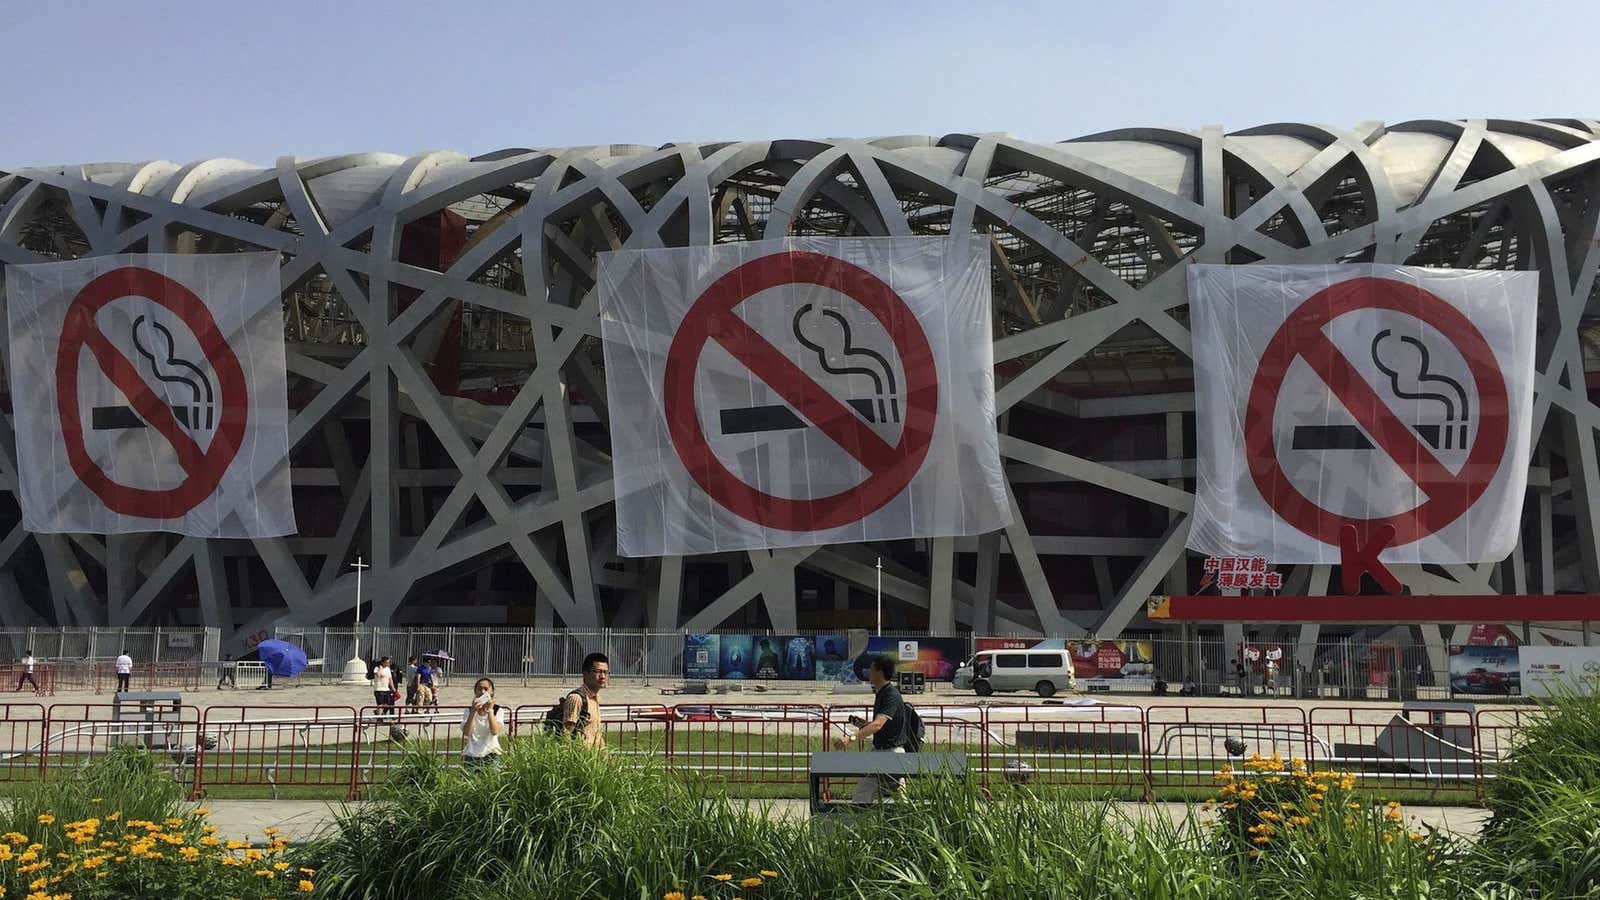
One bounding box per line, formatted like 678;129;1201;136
0;701;1541;801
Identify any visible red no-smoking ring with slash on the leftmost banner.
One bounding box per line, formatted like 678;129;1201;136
56;266;250;519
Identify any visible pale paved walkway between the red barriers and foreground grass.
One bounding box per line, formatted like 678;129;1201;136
206;799;1488;841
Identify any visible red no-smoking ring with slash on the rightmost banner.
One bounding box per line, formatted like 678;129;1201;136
1245;277;1510;544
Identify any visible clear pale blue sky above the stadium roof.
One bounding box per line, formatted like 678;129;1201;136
0;0;1600;170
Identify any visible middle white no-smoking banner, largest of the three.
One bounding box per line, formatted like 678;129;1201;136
598;237;1011;556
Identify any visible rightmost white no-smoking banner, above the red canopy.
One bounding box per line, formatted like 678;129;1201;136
1189;264;1539;564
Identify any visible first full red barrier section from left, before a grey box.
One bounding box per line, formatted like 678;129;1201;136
40;703;200;785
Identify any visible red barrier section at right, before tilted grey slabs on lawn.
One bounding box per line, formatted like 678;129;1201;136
1310;706;1478;796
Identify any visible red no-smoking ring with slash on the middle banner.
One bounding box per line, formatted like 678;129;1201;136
664;251;939;532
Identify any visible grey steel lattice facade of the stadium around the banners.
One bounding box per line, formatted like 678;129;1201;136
0;120;1600;641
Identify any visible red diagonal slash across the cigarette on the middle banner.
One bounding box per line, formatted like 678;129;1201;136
710;311;898;472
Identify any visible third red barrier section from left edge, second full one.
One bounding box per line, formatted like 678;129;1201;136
194;706;362;799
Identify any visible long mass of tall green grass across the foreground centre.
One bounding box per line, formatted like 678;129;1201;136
314;740;1458;900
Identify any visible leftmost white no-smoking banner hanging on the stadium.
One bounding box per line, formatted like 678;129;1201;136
5;253;294;538
